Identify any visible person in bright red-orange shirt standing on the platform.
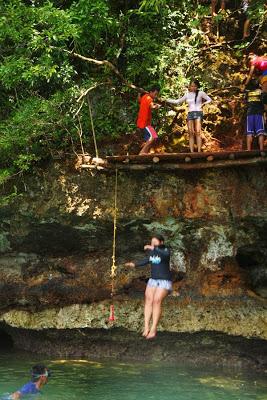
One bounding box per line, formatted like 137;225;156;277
137;86;160;154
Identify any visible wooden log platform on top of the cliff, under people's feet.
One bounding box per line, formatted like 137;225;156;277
102;151;267;170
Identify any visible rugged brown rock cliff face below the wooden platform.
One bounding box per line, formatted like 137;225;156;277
0;164;267;339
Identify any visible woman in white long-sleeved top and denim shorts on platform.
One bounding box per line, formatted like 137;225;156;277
167;80;211;153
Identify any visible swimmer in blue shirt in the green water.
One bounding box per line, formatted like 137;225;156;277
4;365;51;400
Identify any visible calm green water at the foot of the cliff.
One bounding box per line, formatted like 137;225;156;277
0;352;267;400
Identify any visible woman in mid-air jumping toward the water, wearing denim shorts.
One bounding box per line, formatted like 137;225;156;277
125;235;172;339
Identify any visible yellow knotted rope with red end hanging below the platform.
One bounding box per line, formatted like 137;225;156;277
109;168;118;322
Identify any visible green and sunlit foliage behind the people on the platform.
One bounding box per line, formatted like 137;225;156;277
0;0;267;182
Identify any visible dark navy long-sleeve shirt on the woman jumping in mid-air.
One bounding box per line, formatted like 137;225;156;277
135;245;171;281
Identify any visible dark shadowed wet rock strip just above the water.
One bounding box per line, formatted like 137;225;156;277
1;325;267;371
